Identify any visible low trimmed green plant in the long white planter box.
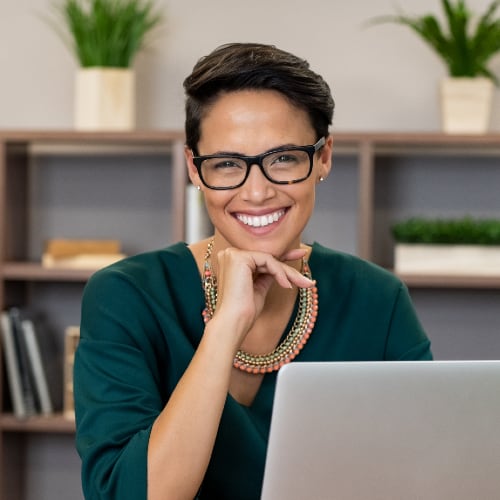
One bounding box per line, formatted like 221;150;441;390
391;216;500;245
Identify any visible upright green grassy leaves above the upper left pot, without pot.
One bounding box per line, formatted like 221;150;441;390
51;0;163;68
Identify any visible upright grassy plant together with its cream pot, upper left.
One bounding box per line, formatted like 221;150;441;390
51;0;163;130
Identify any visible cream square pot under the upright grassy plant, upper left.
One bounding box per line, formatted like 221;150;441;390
75;68;135;130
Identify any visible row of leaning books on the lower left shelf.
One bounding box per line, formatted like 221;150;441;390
0;308;54;419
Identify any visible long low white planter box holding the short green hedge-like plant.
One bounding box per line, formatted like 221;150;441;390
394;243;500;276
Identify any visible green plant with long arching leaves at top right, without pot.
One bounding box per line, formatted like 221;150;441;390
372;0;500;85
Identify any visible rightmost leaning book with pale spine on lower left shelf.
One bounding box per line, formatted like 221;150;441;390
21;319;54;415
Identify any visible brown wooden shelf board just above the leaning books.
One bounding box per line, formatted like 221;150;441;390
2;262;97;282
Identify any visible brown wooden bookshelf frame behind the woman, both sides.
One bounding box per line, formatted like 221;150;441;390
0;130;500;500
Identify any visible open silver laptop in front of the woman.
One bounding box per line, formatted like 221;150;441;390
262;361;500;500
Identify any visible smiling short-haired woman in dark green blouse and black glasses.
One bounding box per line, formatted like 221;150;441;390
74;44;431;500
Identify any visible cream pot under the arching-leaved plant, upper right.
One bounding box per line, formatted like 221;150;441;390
441;78;494;134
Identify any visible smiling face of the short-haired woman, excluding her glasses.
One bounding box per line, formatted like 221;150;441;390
186;90;332;257
